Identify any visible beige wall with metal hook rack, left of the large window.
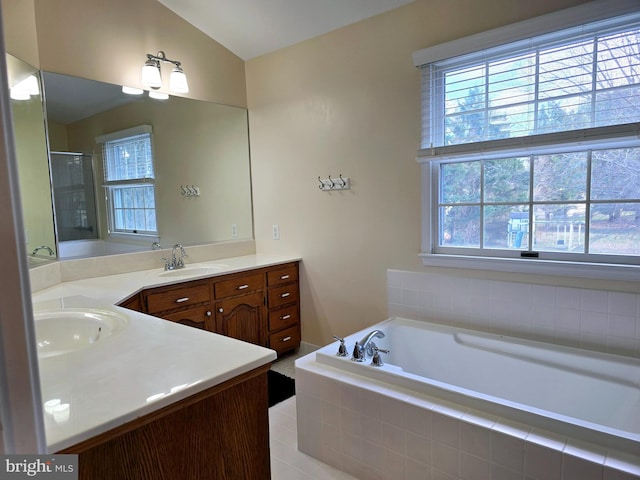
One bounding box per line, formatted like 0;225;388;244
246;0;604;344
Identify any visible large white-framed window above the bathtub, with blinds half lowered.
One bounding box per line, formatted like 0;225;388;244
418;6;640;278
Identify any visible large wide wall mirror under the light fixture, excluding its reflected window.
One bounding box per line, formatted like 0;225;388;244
43;72;253;260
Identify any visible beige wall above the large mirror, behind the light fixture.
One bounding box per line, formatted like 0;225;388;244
33;0;246;107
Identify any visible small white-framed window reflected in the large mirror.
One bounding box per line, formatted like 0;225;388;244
97;126;158;235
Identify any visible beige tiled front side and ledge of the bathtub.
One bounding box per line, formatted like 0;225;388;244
296;342;640;480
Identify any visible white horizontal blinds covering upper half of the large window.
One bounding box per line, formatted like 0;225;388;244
422;6;640;153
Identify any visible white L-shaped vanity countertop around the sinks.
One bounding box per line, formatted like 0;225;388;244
33;255;300;452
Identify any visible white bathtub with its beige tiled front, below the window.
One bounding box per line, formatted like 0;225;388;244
296;318;640;480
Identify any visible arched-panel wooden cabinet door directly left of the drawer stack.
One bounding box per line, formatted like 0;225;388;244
215;292;267;346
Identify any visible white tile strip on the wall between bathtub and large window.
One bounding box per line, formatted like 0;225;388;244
387;270;640;358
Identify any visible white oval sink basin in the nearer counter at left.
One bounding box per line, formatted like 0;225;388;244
34;308;129;358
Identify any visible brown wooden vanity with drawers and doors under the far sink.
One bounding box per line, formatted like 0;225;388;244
120;262;301;356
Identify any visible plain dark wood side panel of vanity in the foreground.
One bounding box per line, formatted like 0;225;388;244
59;365;271;480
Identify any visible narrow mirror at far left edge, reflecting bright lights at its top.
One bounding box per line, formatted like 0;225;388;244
6;53;57;267
